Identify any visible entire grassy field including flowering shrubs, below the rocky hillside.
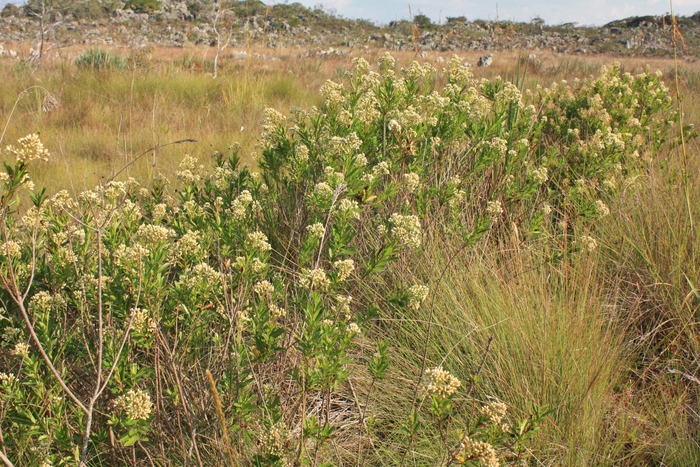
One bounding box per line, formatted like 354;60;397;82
0;42;700;467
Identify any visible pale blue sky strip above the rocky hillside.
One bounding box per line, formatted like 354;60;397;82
0;0;700;26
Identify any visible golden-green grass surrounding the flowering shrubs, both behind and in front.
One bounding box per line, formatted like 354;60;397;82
0;42;700;466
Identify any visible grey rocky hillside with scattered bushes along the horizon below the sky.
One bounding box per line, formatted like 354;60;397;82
0;0;700;58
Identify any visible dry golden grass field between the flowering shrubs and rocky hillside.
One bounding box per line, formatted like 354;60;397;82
0;46;700;192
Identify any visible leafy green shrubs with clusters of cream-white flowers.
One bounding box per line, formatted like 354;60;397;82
0;55;675;466
